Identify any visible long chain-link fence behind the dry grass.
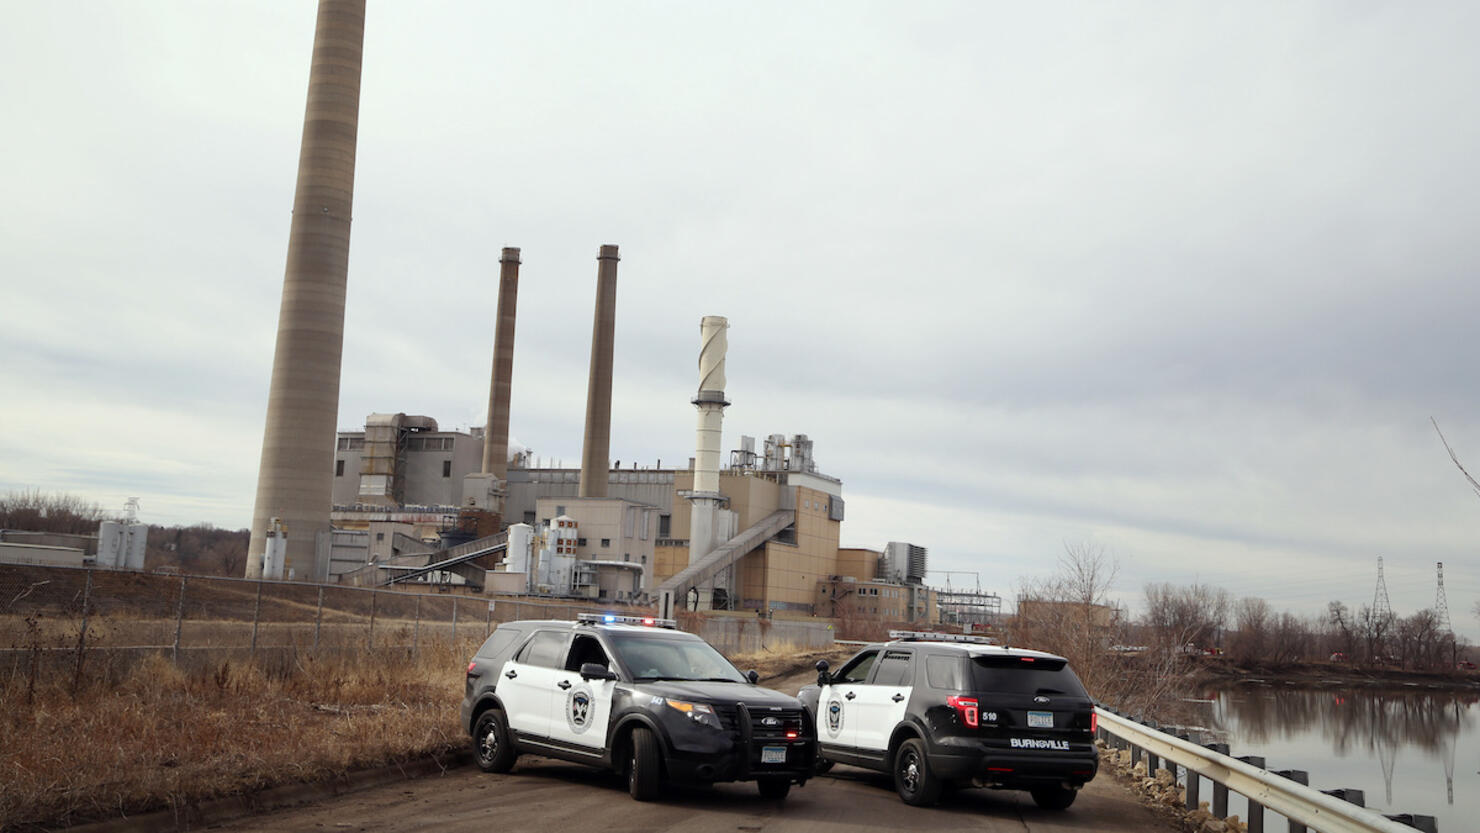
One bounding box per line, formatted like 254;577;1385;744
0;564;588;684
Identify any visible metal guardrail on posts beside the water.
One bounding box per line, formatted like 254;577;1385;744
1095;707;1439;833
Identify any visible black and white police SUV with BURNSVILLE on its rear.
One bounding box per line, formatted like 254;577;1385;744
799;630;1100;809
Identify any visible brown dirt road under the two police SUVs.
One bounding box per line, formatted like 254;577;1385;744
215;756;1171;833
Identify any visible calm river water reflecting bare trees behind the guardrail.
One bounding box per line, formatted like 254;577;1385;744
1190;685;1480;833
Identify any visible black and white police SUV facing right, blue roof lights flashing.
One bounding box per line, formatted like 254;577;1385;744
462;614;817;800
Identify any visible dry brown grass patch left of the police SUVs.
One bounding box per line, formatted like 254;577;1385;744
0;642;475;830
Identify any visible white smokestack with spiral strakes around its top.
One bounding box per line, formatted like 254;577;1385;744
688;315;730;564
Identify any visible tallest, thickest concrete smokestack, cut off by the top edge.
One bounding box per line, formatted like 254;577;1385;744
247;0;366;577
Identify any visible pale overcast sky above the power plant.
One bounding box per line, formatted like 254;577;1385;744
0;0;1480;639
